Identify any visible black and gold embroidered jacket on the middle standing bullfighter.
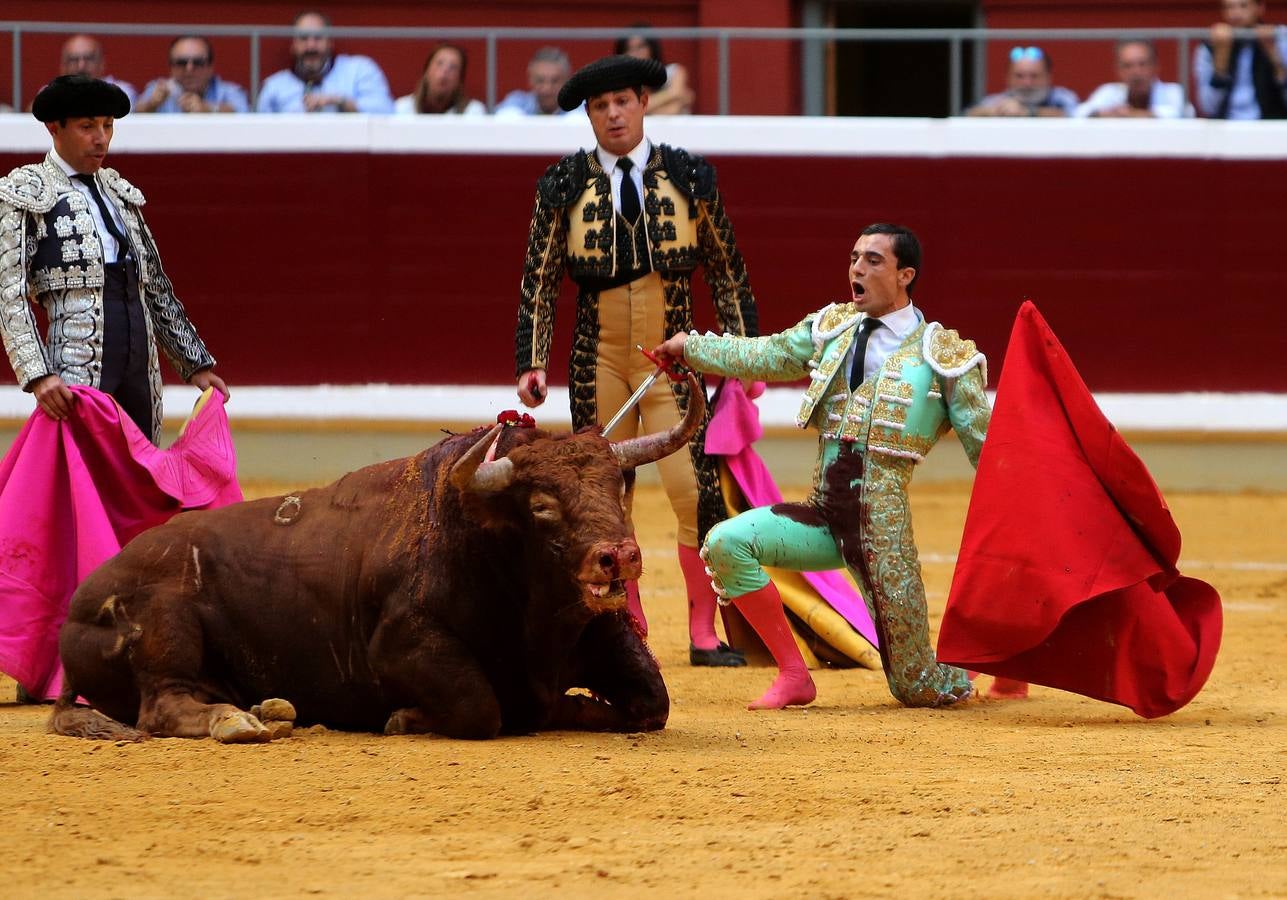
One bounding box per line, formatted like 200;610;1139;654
515;144;758;375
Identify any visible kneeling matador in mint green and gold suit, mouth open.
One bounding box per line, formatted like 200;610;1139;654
658;224;990;709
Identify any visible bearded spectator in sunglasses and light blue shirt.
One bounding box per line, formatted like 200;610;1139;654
255;10;394;113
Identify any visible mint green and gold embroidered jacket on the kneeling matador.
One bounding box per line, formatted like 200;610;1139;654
685;303;991;474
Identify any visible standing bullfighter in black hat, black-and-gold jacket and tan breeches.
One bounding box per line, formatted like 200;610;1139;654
516;55;758;666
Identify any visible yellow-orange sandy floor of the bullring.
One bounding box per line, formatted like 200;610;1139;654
0;487;1287;897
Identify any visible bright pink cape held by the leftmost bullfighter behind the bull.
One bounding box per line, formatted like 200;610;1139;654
0;385;242;698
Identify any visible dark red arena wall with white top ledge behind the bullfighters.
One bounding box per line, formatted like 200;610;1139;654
0;117;1287;391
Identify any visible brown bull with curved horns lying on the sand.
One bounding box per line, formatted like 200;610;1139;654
49;377;705;742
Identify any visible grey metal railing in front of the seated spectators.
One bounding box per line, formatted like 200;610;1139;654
0;22;1254;116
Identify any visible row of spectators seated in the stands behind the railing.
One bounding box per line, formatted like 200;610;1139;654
40;0;1287;120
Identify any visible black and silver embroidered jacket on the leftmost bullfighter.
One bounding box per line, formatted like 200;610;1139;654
0;157;215;442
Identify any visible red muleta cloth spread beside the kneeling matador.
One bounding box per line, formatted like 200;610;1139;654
938;303;1221;718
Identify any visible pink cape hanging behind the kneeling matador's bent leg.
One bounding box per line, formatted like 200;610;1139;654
705;379;878;646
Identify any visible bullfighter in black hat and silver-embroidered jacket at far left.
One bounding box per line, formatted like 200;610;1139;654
0;75;228;443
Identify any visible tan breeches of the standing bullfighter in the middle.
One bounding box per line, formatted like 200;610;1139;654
595;272;698;547
